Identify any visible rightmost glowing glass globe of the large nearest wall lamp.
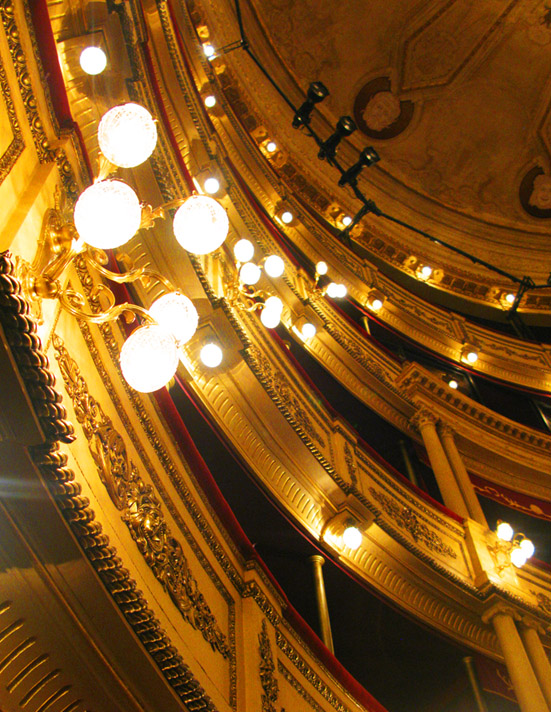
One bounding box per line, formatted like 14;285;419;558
173;195;230;255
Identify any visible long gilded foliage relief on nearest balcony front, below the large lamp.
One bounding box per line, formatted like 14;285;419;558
52;335;230;658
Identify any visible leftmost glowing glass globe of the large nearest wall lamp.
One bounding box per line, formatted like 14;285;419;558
74;180;142;250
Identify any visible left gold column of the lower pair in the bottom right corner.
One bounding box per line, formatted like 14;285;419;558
482;604;549;712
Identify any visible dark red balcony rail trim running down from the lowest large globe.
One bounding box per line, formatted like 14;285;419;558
153;388;387;712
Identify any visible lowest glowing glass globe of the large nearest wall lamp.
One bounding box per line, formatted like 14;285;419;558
120;324;178;393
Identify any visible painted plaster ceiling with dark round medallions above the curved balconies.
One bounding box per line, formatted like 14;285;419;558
243;0;551;277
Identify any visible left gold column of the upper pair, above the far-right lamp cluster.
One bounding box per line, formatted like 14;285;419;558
411;410;469;519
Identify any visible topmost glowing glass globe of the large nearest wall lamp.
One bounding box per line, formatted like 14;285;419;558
98;103;157;168
